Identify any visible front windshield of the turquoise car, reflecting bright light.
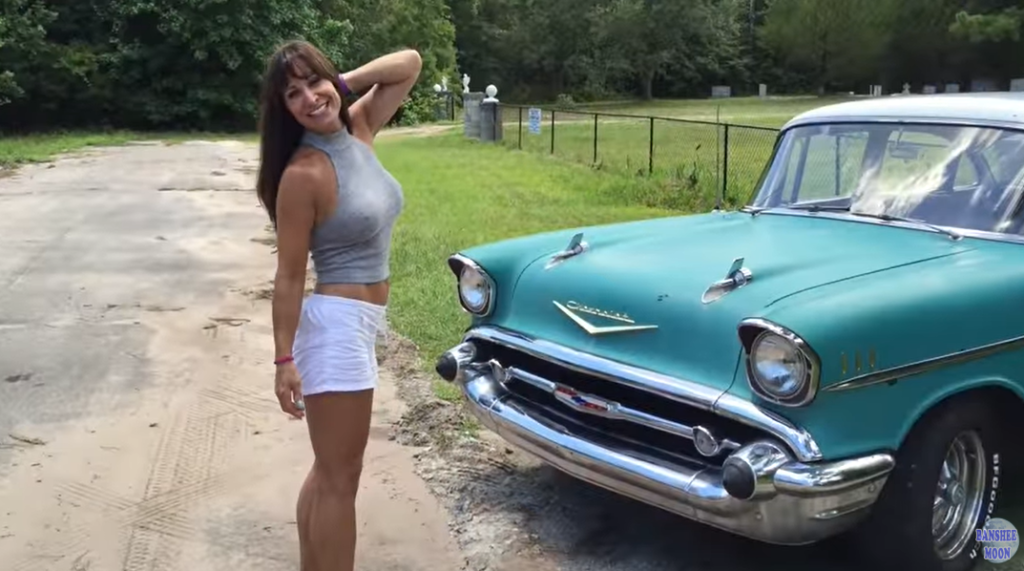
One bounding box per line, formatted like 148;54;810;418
750;123;1024;234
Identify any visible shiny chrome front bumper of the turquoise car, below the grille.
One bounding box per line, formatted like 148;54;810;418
442;354;894;545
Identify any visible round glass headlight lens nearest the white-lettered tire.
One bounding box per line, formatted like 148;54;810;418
751;333;809;400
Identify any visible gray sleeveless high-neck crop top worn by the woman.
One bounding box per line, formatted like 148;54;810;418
302;129;403;283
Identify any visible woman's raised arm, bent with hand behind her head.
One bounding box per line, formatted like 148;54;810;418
341;49;423;136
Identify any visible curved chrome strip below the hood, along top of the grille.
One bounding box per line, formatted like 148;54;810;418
463;325;822;462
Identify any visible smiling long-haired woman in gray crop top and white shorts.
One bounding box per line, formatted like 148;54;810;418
257;41;422;571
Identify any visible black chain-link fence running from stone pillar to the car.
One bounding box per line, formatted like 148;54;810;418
500;103;778;207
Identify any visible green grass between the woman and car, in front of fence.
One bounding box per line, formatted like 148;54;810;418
377;131;679;398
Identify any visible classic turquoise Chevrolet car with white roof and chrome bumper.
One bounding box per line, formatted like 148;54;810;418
436;93;1024;571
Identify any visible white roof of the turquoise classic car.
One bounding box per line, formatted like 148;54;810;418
782;91;1024;130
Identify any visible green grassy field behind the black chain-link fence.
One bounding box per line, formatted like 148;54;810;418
489;97;846;208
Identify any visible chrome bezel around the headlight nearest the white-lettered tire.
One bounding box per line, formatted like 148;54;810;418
738;318;821;407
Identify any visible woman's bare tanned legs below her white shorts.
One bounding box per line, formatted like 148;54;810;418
296;389;374;571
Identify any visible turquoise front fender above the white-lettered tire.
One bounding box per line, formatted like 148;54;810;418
732;240;1024;458
